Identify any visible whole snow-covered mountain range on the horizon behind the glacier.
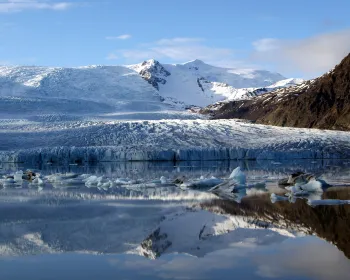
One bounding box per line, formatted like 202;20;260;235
0;60;302;112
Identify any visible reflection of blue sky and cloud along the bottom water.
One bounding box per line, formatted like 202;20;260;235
0;237;350;280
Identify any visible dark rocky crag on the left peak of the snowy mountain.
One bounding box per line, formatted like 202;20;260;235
140;60;171;90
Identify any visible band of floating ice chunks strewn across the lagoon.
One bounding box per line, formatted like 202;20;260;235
0;167;350;206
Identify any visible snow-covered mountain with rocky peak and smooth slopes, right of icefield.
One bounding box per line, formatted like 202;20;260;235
128;59;297;106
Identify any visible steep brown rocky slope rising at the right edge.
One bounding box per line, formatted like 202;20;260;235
202;54;350;130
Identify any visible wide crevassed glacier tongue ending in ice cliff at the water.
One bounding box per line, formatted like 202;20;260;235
0;119;350;164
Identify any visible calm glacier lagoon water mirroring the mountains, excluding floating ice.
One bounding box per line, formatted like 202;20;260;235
0;160;350;279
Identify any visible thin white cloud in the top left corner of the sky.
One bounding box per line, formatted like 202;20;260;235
0;0;73;13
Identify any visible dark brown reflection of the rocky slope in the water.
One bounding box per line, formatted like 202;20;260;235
202;188;350;259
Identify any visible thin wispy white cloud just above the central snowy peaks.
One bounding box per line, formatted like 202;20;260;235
107;37;246;67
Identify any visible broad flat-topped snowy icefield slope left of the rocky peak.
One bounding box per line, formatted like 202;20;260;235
0;66;161;111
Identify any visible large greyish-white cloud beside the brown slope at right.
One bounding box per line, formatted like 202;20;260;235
251;29;350;76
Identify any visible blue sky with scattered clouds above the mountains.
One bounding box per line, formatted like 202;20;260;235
0;0;350;78
